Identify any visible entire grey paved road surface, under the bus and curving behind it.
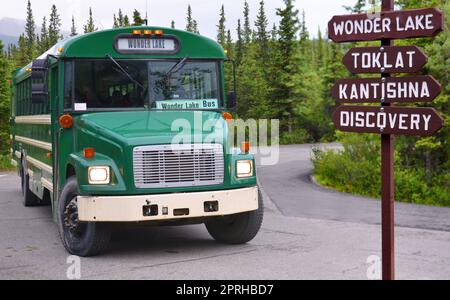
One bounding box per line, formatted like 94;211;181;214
0;146;450;279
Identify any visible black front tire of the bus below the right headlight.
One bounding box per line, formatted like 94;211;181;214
205;191;264;245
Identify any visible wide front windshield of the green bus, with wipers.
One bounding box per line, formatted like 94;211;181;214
64;58;223;111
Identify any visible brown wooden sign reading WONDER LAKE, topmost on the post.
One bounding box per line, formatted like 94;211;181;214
328;8;444;43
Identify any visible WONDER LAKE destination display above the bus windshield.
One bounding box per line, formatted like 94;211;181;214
117;37;177;53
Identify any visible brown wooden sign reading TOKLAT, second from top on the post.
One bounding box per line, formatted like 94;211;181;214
342;46;428;74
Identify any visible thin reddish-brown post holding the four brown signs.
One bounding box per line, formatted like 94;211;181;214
381;0;395;280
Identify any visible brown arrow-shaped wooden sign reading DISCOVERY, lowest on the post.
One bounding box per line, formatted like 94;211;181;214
333;106;444;136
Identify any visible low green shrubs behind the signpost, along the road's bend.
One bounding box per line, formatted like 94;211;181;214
312;134;450;206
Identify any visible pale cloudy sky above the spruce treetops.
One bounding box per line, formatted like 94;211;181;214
0;0;356;38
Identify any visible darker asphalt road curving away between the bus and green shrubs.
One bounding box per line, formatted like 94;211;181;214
258;144;450;231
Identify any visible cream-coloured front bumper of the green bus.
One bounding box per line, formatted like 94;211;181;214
77;186;258;222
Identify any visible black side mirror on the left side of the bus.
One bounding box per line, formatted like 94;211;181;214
31;59;48;104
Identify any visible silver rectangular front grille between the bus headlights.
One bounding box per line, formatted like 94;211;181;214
133;144;224;188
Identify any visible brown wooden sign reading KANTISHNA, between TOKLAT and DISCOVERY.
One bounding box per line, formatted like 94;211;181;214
331;76;441;103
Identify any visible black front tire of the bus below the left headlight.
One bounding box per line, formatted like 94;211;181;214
58;177;111;257
